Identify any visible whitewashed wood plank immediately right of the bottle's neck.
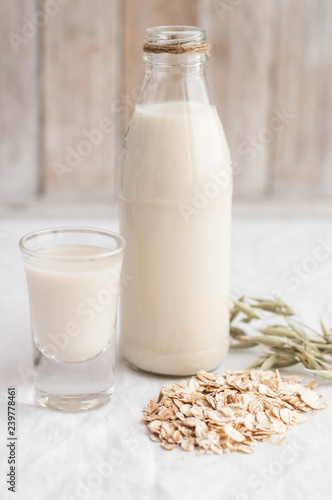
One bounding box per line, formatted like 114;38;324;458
199;0;278;198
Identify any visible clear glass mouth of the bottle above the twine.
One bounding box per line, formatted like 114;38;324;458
145;26;206;48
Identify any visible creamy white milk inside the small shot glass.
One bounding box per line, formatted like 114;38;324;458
24;245;122;363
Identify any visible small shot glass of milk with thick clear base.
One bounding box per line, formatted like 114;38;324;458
19;227;125;412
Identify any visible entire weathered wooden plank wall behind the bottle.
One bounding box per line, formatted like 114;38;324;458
0;0;332;203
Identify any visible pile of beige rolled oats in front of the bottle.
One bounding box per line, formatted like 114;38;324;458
143;370;327;454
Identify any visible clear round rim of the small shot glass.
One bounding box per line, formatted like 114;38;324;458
18;226;126;262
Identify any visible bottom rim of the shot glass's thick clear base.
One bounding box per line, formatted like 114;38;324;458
35;388;113;413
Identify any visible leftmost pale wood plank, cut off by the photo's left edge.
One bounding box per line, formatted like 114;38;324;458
0;0;39;200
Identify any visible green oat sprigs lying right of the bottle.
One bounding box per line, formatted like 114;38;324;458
230;297;332;381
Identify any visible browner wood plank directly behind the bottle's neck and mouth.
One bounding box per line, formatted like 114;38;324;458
123;0;198;126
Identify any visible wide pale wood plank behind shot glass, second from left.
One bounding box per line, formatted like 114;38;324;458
43;0;123;199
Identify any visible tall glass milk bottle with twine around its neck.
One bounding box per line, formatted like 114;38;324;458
118;26;232;375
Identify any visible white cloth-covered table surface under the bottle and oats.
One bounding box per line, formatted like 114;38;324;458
0;212;332;500
